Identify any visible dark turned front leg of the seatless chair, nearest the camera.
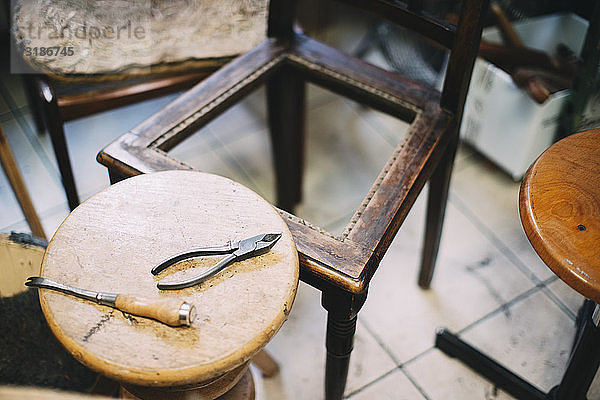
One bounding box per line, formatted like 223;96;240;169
322;291;367;400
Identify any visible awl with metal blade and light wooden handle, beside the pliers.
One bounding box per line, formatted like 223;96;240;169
25;276;196;326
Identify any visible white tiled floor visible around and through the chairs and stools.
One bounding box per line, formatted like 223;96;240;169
0;6;598;400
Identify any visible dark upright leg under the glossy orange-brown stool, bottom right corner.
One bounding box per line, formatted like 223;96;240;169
552;304;600;400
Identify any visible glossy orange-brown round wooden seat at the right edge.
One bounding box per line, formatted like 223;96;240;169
519;129;600;303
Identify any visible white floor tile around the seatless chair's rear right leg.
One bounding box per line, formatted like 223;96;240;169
360;192;533;362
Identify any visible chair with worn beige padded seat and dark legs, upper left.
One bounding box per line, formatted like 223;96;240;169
6;0;267;210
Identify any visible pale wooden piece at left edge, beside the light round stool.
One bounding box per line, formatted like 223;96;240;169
0;234;44;297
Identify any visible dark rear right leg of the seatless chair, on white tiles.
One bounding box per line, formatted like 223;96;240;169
419;137;458;289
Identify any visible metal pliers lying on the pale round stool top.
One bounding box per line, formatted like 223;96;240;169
151;233;281;290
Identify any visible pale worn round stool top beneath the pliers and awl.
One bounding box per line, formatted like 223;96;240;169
40;171;299;387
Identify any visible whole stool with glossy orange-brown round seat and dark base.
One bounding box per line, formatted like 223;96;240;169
436;129;600;400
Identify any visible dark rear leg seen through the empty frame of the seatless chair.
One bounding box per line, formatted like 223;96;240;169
267;68;305;212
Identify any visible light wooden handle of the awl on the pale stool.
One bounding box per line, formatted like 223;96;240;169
115;294;195;326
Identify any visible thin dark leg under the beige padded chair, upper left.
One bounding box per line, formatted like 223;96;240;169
39;81;79;211
